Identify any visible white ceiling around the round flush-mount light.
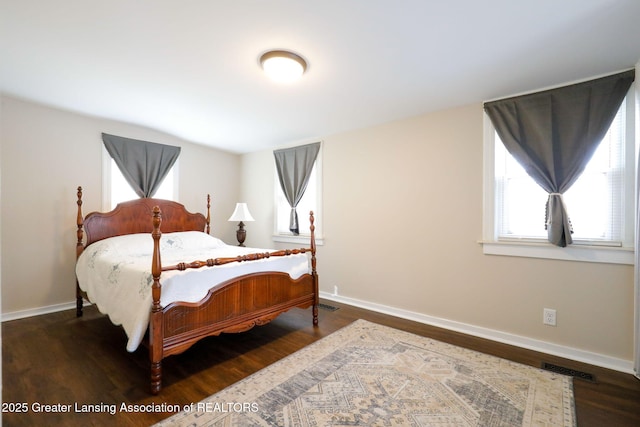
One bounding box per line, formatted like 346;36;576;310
0;0;640;153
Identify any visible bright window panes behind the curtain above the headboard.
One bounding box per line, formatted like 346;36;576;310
102;149;180;210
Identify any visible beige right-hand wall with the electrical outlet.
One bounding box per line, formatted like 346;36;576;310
242;104;633;361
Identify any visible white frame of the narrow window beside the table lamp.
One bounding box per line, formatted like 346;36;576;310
272;140;324;246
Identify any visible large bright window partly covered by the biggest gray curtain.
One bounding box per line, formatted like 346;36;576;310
483;86;635;264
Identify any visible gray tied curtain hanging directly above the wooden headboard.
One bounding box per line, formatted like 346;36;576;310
102;133;180;197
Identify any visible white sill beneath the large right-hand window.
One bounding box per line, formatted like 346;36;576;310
478;241;634;265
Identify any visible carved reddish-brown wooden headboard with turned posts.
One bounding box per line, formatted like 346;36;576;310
77;187;211;254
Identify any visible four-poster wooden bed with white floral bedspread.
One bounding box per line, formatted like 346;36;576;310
76;187;318;394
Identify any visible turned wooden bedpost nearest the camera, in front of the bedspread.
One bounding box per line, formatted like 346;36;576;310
149;206;163;394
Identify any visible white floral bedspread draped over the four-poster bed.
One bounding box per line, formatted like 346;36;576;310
76;231;310;351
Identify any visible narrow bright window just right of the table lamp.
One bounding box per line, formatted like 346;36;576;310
273;148;322;245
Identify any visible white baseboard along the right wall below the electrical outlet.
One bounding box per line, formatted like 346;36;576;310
320;292;634;375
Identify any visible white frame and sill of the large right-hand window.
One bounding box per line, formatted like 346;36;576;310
480;84;637;265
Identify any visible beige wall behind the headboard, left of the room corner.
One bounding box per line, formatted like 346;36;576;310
0;96;240;314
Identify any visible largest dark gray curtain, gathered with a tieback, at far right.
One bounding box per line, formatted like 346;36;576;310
484;70;635;247
